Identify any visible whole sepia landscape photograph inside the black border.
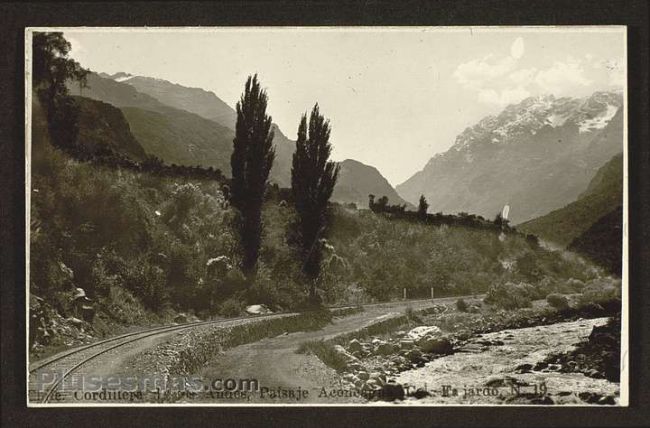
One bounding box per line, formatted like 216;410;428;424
26;25;628;407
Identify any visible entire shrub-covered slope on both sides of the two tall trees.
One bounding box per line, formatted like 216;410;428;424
31;85;598;330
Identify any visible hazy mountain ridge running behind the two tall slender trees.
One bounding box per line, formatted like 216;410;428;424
68;73;404;196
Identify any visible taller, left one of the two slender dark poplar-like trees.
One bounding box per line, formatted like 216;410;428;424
230;74;275;276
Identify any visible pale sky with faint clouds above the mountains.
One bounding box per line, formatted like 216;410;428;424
63;27;626;185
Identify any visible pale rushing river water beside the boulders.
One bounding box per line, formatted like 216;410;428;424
395;318;619;405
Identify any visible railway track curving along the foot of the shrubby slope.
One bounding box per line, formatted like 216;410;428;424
28;296;470;403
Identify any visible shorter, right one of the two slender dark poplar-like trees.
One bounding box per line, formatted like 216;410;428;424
291;104;339;300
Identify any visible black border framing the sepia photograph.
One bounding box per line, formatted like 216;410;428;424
0;0;650;427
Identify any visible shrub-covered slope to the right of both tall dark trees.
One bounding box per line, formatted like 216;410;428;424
324;206;599;300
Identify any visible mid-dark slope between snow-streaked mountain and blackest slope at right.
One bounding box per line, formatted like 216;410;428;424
517;153;623;247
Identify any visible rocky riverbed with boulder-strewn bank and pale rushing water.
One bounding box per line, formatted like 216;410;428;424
302;301;620;404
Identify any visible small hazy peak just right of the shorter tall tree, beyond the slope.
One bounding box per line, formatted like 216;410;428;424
332;159;414;209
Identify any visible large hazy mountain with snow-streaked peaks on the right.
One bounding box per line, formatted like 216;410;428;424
396;92;623;223
